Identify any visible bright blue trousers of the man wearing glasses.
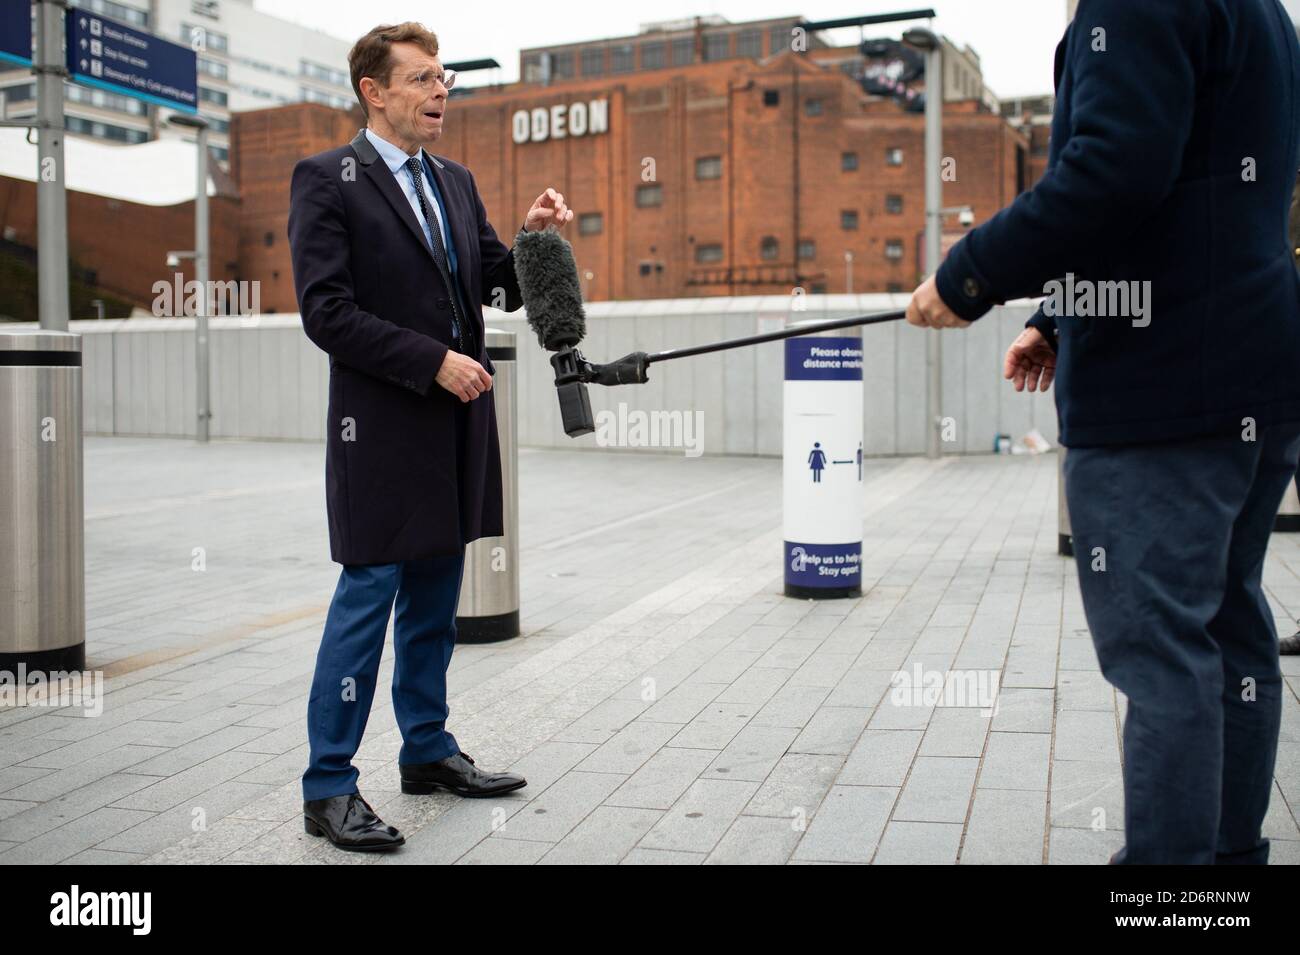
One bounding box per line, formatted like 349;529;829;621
303;552;464;799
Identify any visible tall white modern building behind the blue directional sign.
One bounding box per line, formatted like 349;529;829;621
0;0;354;161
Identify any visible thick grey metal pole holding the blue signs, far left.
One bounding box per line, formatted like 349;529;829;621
31;0;69;331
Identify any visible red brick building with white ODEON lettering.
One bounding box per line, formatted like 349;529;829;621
416;27;1032;299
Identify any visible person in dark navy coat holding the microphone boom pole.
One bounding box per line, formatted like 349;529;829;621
907;0;1300;864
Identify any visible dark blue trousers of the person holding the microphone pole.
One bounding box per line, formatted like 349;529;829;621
1065;425;1300;864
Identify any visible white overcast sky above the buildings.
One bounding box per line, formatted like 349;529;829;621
255;0;1300;99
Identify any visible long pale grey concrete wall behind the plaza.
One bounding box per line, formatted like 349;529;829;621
63;295;1057;455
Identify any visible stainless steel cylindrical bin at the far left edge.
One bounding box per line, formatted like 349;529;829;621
0;329;86;673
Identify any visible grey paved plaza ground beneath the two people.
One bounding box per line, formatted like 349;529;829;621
0;438;1300;864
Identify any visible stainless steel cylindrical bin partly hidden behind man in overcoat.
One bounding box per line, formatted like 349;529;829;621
456;329;519;643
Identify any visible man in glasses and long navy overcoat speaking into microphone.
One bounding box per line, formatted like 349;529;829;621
289;23;573;850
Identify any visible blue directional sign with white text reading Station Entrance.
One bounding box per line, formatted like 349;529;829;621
68;8;199;113
